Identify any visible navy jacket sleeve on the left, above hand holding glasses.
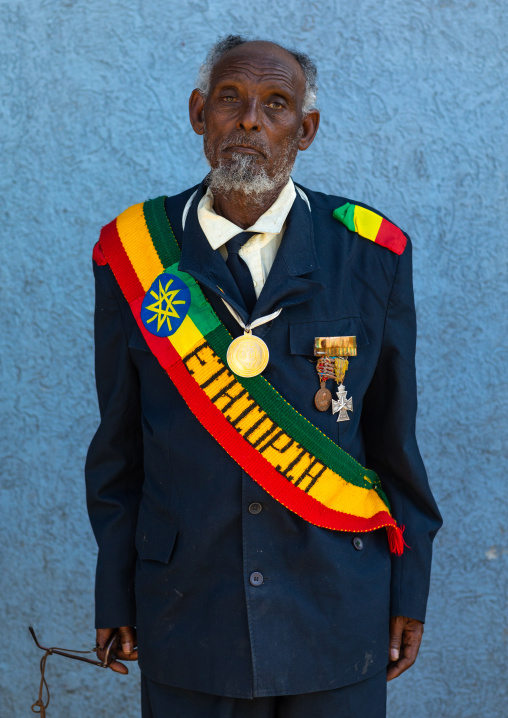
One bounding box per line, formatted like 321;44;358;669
85;262;143;628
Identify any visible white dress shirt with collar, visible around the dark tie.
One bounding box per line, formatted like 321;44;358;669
198;184;296;297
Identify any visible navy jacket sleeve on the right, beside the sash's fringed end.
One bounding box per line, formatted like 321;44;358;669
362;240;442;621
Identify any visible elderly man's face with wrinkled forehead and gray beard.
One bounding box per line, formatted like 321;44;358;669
197;42;310;191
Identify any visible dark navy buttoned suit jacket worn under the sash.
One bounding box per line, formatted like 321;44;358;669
86;185;441;698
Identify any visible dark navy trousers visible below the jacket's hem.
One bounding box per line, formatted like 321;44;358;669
141;670;386;718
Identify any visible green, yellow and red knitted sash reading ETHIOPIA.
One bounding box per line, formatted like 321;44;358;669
94;197;404;555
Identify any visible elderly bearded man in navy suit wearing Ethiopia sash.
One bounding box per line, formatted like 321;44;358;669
86;36;441;718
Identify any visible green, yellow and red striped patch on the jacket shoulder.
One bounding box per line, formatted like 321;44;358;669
333;202;407;254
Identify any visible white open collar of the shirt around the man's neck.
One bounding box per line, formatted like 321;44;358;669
198;178;296;249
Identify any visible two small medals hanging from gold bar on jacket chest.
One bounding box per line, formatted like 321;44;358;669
314;337;356;421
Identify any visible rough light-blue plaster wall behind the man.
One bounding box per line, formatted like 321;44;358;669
0;0;508;718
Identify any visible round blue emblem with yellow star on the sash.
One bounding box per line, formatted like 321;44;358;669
141;272;191;337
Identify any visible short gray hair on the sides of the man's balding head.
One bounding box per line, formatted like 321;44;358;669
197;35;317;115
